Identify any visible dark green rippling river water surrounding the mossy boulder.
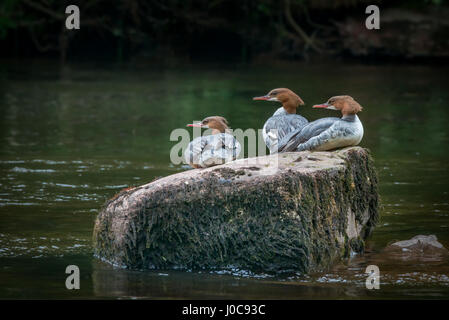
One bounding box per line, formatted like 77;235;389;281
0;63;449;299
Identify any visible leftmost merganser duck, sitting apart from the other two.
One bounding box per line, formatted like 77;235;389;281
184;116;241;168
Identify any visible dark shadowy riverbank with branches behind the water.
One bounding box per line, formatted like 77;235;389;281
0;0;449;64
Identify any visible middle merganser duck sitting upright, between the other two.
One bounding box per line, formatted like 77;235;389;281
253;88;308;153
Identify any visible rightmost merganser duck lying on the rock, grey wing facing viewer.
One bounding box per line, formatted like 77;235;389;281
279;95;363;152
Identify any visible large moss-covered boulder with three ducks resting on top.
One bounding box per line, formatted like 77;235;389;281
94;147;378;273
